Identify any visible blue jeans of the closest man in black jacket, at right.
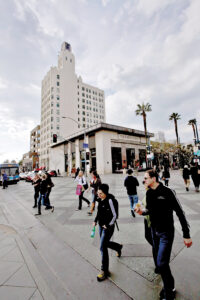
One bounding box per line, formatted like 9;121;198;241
151;229;174;295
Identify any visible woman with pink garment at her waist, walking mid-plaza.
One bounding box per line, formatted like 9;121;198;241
74;171;90;210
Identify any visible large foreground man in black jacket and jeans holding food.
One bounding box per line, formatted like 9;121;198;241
135;170;192;300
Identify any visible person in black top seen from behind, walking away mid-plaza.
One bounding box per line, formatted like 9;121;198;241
124;169;139;218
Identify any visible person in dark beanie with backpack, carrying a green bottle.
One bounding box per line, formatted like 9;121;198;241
93;184;123;281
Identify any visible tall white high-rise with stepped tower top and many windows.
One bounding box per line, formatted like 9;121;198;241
40;42;105;169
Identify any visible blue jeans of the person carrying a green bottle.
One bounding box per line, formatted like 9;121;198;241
99;225;121;273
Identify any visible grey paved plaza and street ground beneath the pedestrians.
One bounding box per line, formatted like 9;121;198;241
0;171;200;300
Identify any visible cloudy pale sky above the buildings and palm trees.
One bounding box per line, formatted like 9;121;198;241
0;0;200;162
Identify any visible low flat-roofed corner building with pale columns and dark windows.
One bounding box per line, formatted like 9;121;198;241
50;123;153;174
